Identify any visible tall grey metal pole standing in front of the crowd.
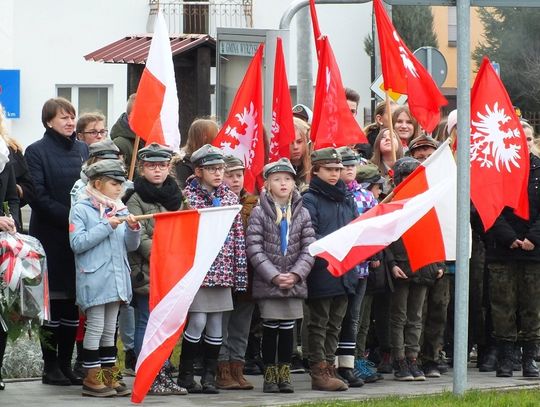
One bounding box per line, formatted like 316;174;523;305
453;0;471;395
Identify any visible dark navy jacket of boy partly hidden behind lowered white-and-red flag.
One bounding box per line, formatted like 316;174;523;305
303;177;358;299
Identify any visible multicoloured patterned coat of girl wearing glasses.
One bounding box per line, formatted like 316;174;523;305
184;177;247;291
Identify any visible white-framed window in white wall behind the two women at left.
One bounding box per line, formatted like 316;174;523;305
56;85;112;122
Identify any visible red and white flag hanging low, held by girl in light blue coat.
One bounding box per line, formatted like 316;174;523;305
131;205;241;403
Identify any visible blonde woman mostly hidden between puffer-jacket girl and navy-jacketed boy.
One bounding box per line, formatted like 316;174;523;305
290;117;311;192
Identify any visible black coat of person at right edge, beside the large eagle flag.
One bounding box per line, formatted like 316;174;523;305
486;154;540;263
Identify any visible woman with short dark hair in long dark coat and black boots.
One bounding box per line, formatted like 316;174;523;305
25;98;88;386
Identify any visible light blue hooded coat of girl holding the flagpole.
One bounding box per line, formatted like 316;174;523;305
69;199;141;311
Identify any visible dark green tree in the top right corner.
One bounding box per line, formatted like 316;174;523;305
473;7;540;111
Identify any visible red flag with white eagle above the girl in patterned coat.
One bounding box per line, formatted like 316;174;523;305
212;44;264;192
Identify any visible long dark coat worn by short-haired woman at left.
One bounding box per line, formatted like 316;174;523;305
25;129;88;299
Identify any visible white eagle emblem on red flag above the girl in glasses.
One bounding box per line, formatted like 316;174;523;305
221;102;259;168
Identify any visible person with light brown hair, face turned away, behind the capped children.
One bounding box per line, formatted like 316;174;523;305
172;119;219;189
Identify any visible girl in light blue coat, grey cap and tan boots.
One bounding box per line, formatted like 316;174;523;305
69;160;140;397
